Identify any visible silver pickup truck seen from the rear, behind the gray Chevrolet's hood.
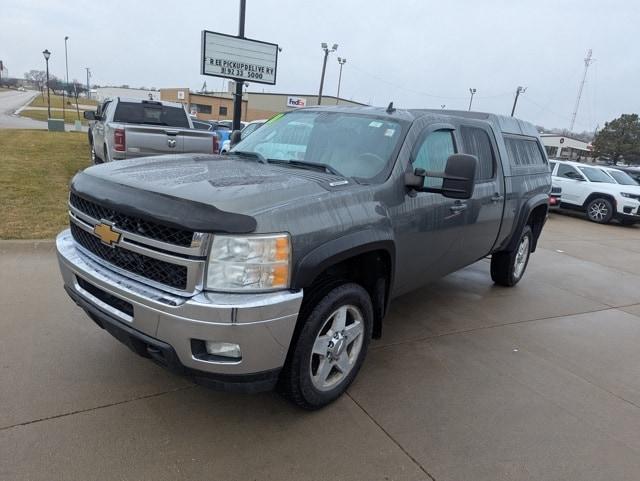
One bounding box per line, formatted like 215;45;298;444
84;97;220;164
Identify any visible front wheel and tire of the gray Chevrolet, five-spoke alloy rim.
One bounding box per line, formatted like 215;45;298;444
278;283;373;410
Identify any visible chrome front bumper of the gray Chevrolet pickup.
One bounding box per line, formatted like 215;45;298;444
56;230;302;391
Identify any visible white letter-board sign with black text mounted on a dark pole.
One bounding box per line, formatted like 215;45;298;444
200;30;278;85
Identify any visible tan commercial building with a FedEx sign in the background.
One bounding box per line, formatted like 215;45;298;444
160;88;365;122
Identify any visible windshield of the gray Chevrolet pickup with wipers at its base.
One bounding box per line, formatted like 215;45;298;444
231;111;402;180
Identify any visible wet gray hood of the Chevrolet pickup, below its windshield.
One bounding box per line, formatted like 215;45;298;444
72;154;354;232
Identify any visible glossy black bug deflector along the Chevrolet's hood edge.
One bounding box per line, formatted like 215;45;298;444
71;172;257;234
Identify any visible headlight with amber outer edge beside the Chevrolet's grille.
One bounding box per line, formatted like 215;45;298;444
206;234;291;292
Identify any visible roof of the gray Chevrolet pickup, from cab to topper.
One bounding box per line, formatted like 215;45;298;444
303;105;539;137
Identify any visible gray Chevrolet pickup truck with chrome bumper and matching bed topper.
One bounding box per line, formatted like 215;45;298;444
57;106;551;409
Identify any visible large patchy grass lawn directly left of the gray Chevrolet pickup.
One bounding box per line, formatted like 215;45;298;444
0;129;90;239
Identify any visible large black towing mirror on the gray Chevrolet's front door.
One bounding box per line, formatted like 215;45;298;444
405;154;478;199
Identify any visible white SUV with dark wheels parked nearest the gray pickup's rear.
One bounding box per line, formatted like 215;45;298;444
549;160;640;224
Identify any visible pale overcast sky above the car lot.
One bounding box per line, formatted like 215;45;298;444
0;0;640;132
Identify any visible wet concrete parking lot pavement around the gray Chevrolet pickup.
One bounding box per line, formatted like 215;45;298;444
0;214;640;481
